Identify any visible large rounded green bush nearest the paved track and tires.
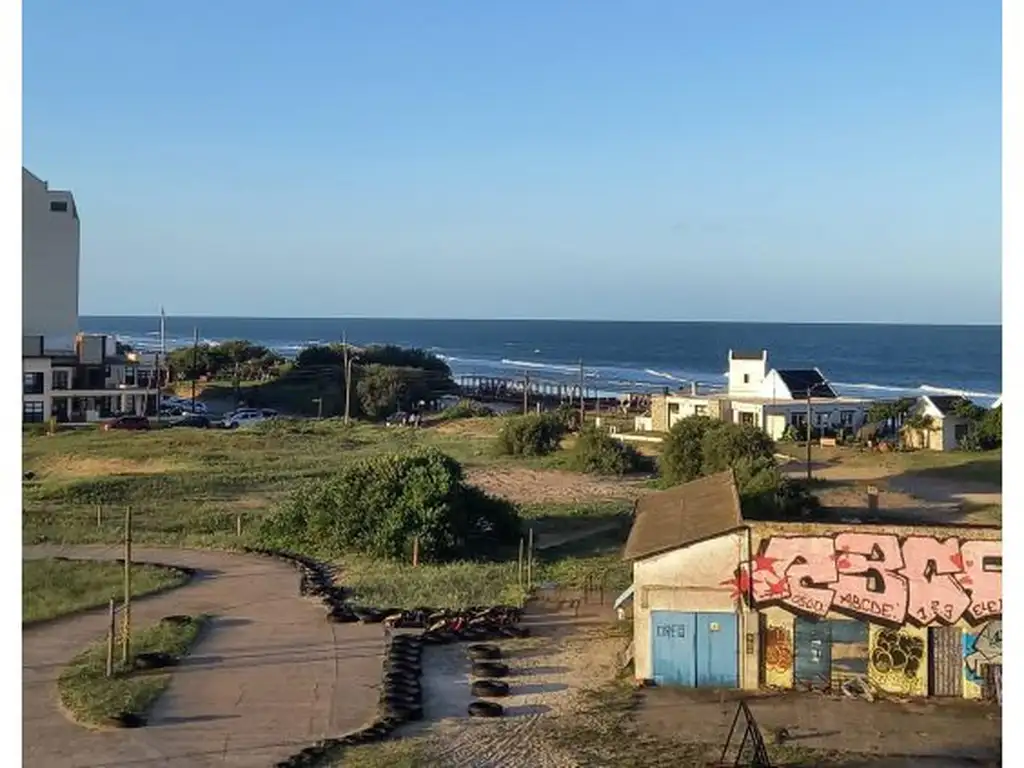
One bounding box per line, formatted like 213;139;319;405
258;449;519;561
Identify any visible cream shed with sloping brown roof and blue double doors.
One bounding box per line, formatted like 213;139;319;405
624;471;758;688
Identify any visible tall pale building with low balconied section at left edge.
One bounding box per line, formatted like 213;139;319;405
22;168;159;423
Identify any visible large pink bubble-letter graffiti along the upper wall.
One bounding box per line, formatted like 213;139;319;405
740;532;1002;626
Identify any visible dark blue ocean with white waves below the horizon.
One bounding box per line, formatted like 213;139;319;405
80;315;1002;406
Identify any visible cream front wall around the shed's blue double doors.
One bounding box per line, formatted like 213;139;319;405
633;529;758;688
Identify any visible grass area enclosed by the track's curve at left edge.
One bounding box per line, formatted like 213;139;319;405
22;558;188;624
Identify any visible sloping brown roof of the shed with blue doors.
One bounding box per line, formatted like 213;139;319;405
623;470;743;560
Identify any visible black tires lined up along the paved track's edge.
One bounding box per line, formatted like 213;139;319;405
248;549;529;768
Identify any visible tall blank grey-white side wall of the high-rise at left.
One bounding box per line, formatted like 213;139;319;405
22;168;80;351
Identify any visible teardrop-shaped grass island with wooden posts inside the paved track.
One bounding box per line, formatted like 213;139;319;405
57;615;208;726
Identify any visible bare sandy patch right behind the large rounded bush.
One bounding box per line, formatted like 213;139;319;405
466;467;647;504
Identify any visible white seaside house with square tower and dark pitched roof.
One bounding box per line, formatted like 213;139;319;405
651;349;870;439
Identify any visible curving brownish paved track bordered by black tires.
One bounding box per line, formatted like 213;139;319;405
23;546;384;768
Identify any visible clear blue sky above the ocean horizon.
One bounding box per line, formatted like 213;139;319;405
24;0;1001;323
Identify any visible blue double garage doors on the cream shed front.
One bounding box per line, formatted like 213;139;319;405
650;610;739;688
